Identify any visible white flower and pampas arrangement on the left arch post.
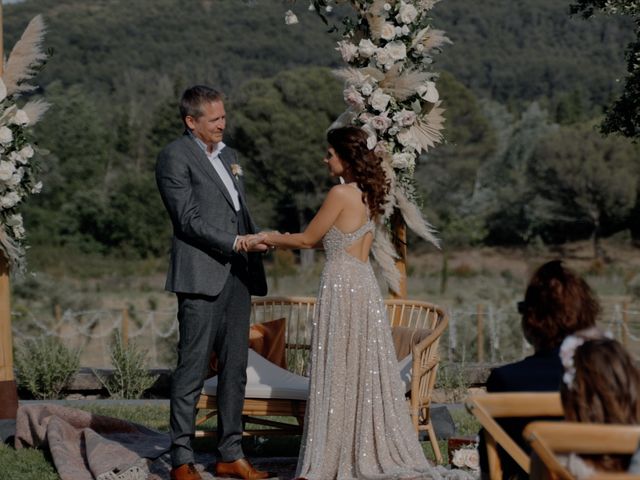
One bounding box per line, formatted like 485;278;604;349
0;16;48;269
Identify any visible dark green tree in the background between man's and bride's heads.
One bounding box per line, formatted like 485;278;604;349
228;67;344;262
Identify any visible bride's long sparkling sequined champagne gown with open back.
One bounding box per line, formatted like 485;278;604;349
296;220;441;480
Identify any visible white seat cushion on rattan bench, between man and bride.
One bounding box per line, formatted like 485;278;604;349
202;349;309;400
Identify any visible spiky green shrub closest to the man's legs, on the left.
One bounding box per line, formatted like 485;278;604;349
94;332;158;399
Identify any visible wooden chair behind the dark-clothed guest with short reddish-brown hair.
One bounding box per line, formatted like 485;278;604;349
467;392;564;480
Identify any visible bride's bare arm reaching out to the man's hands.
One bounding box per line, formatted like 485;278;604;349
262;185;348;249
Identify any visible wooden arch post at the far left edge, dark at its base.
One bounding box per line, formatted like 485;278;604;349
0;0;18;420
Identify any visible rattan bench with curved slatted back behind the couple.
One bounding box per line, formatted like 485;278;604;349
196;297;449;463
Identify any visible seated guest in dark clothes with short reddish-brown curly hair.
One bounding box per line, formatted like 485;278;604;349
479;260;600;478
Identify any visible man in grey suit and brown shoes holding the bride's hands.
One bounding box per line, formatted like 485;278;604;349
156;86;276;480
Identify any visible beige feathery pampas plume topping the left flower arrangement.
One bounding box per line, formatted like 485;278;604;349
2;15;47;95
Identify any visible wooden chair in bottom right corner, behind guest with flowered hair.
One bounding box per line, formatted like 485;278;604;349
524;422;640;480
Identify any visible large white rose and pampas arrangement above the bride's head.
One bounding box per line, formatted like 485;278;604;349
285;0;451;290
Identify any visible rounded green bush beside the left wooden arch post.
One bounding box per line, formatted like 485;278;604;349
16;337;80;400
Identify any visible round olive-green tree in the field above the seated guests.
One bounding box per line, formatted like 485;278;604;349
529;120;638;257
